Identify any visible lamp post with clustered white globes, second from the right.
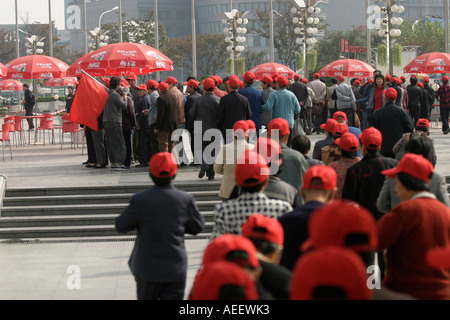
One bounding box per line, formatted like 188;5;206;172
291;0;321;78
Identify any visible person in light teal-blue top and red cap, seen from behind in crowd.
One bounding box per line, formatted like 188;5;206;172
262;76;301;147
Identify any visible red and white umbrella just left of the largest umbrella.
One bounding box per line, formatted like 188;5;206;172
5;54;69;79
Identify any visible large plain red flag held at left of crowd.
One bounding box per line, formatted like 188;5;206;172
68;72;108;130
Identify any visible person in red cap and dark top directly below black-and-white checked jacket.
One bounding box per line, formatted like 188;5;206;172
242;213;291;300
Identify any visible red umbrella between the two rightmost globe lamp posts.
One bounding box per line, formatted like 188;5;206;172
318;59;375;77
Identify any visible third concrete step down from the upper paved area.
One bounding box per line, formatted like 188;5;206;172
0;211;214;230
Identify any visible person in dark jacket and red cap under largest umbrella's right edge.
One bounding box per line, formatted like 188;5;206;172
153;82;178;152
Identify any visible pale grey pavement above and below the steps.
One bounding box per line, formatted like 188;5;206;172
0;123;450;300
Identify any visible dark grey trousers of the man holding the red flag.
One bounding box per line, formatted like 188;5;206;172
103;121;127;166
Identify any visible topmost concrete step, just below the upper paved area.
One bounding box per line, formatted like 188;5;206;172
3;190;220;207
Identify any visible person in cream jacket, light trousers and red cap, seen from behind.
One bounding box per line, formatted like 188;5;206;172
214;120;250;200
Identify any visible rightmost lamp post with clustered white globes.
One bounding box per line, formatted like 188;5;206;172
374;0;405;75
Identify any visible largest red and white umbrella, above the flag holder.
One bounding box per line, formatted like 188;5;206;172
75;42;173;76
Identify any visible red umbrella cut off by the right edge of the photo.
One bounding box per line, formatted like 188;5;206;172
403;52;450;73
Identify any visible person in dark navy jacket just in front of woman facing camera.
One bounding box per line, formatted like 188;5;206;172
369;87;414;158
